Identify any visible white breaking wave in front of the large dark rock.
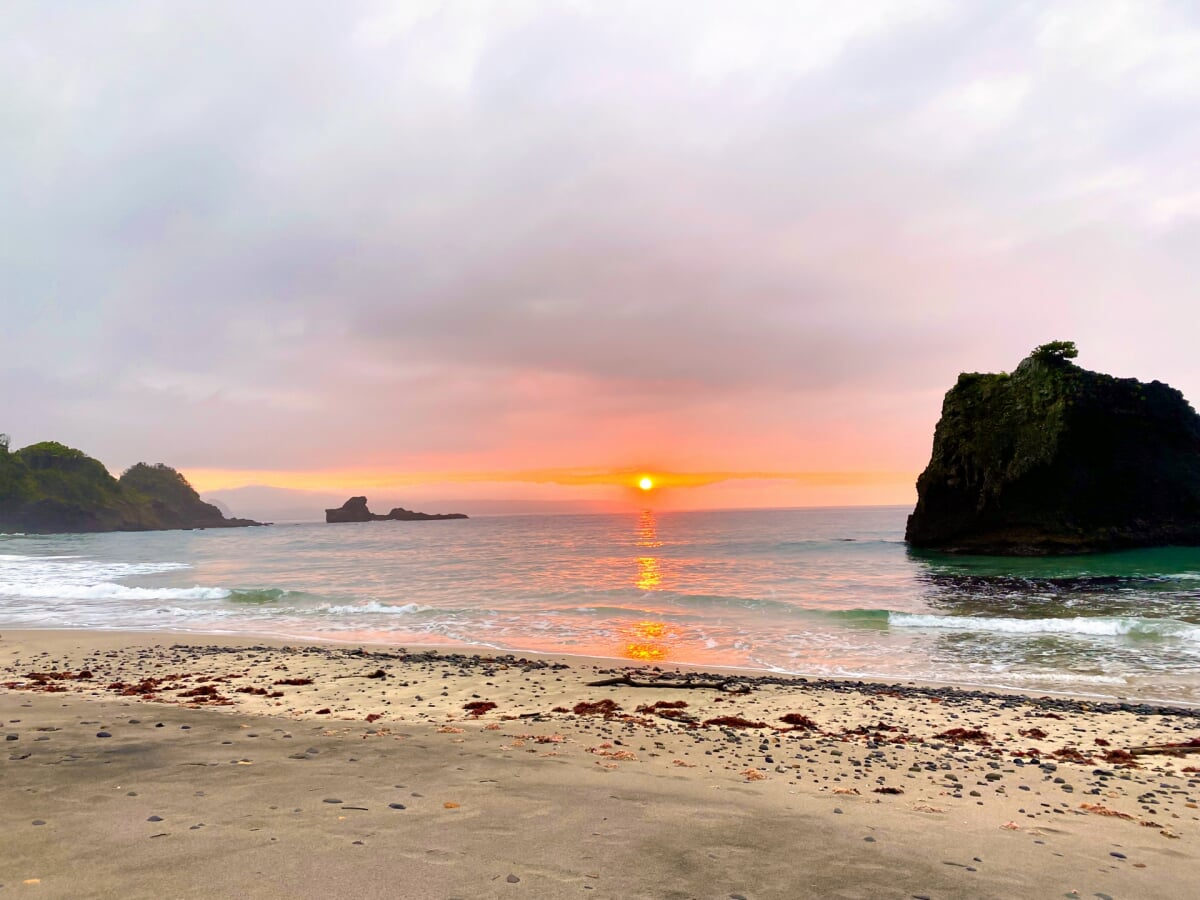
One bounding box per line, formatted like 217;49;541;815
888;612;1200;642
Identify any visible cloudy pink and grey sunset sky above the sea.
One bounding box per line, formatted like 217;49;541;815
0;0;1200;515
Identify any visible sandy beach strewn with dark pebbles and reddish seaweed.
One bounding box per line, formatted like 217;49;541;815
0;631;1200;900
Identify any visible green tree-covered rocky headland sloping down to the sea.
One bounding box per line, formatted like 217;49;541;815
0;439;260;534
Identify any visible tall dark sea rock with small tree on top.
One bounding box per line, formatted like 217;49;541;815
905;342;1200;556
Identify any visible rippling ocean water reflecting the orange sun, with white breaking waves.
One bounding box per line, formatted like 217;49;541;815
0;508;1200;703
